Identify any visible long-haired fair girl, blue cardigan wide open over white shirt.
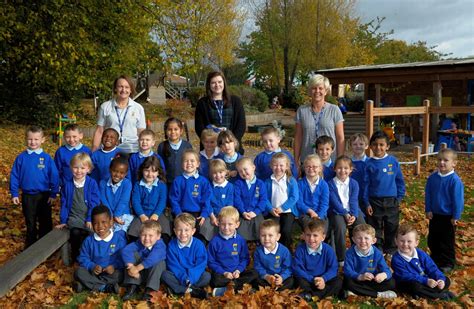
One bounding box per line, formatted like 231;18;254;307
265;152;299;248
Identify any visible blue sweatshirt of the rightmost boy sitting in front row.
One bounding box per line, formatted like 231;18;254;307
392;248;446;285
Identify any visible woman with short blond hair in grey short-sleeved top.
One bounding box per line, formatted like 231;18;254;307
294;74;344;166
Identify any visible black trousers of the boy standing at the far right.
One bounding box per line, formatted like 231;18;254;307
428;214;456;267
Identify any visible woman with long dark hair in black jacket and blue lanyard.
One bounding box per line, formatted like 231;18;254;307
194;71;246;154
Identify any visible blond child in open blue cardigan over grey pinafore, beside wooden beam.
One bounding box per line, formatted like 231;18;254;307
56;152;100;261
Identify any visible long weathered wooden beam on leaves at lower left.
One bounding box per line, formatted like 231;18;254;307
0;229;69;297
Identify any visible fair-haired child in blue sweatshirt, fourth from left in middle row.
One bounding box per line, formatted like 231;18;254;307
169;149;214;243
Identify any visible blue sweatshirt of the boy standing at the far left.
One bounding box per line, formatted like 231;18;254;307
10;150;59;198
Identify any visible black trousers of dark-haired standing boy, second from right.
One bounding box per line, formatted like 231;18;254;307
366;197;400;254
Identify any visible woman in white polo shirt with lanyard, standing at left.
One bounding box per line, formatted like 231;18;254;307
92;75;146;154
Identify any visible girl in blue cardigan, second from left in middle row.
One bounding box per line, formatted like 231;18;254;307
99;157;133;232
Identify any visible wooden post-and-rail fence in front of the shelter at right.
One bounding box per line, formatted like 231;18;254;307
365;100;474;175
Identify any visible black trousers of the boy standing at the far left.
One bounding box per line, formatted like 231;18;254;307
21;192;53;247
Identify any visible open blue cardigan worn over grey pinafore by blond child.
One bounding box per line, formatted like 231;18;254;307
59;176;100;224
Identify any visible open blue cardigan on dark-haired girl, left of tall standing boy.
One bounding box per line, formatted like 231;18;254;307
328;177;359;217
